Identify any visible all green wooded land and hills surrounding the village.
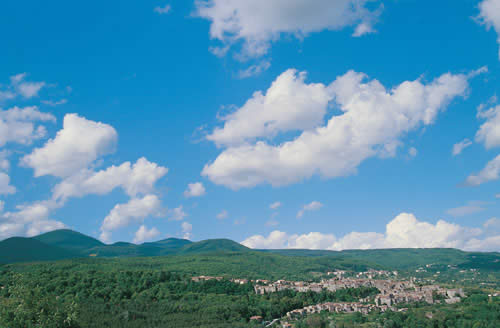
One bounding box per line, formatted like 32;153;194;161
0;230;500;328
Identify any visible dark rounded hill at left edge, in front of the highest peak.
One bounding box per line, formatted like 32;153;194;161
0;237;78;264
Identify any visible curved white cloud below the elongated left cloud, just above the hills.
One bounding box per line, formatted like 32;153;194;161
100;195;163;242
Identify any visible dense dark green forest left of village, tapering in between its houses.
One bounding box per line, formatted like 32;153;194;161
0;260;378;327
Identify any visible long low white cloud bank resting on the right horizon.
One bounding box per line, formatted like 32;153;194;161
242;213;500;251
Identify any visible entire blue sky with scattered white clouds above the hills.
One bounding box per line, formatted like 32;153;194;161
0;0;500;251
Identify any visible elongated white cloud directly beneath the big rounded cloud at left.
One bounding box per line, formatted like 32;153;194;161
53;157;168;201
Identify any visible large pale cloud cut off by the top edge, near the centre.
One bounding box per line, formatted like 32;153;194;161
196;0;380;57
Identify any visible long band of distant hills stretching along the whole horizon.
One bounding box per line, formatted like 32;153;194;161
0;229;500;271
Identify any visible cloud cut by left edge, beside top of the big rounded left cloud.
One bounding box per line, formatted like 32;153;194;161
0;106;56;146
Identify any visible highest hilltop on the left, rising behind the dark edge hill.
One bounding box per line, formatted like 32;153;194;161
33;229;105;253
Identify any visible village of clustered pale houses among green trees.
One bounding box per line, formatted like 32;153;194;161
192;270;465;327
